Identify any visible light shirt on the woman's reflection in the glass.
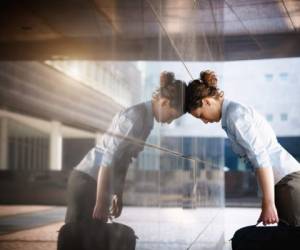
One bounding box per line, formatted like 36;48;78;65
75;101;154;181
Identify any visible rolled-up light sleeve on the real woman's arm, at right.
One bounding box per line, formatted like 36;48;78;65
231;114;272;168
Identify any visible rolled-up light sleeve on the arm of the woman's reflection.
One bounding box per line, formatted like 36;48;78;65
101;115;134;167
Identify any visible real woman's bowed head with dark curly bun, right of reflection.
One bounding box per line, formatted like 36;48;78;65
186;70;224;123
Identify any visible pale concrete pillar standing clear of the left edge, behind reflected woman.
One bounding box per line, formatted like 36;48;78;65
49;121;62;170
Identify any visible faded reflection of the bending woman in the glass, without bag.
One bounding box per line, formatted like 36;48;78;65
65;72;186;222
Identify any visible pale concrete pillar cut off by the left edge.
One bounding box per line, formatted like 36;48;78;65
0;117;8;170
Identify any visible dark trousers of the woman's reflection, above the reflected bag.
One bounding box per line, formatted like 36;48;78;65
65;170;97;223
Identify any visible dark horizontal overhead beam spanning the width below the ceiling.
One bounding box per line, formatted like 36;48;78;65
0;33;300;61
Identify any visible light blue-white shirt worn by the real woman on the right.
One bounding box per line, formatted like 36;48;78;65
222;99;300;184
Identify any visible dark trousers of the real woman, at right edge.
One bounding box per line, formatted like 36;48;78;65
275;171;300;226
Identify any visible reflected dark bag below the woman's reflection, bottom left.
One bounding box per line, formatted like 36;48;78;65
57;220;137;250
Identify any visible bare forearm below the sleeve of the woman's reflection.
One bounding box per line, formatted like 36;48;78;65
93;166;110;222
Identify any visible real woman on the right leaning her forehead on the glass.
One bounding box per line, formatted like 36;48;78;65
187;71;300;226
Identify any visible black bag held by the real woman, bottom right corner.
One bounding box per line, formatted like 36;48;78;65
231;225;300;250
